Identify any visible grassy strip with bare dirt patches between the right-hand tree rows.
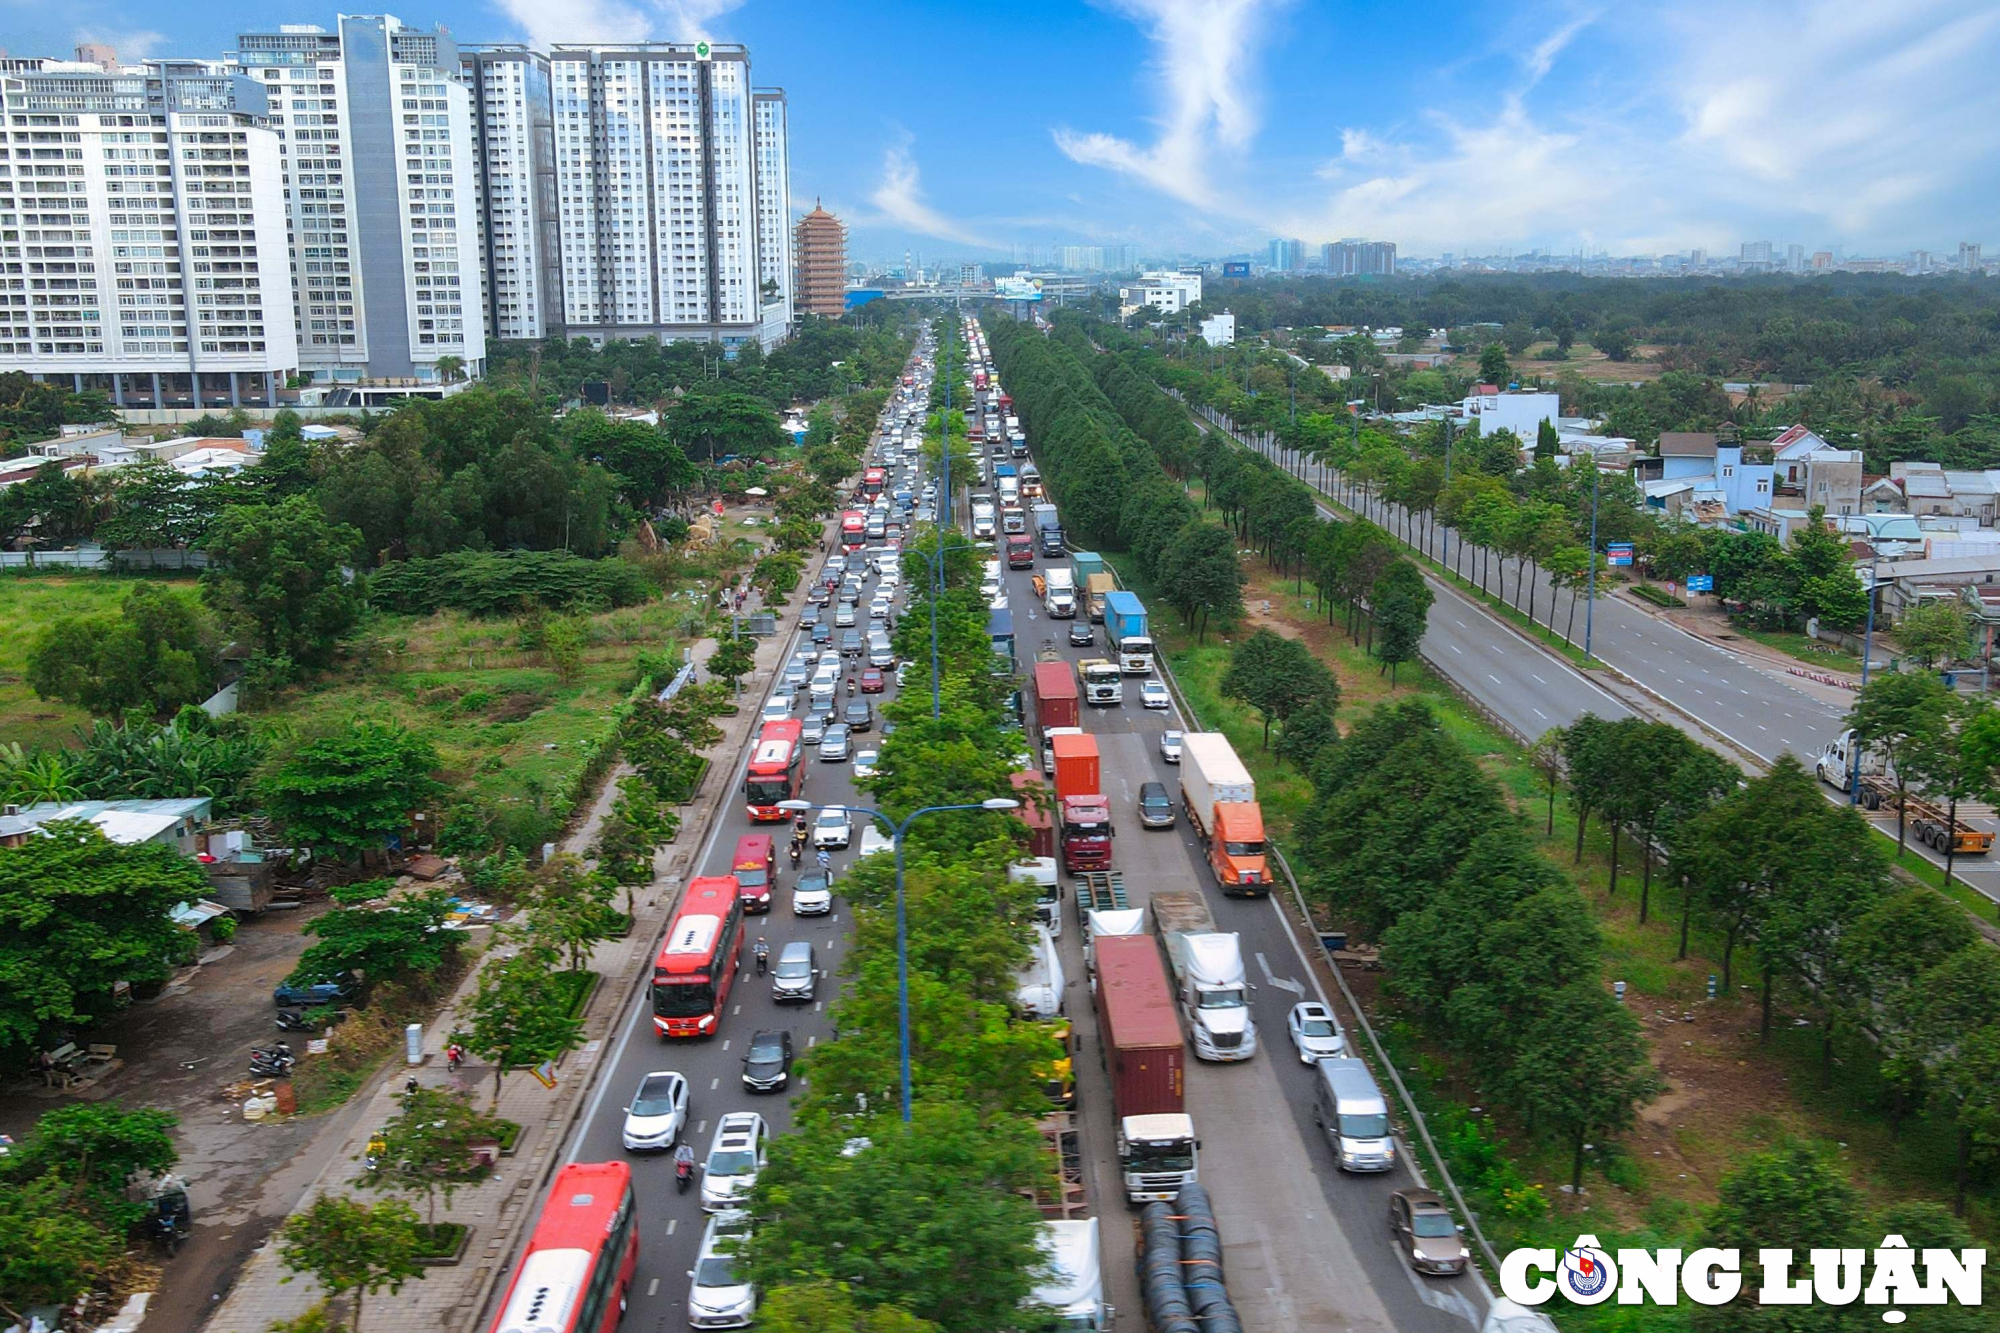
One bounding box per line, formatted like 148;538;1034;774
1112;528;2000;1304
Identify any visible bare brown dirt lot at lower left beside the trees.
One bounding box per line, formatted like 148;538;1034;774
0;909;376;1333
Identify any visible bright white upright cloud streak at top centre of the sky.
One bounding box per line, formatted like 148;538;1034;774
1054;0;1278;208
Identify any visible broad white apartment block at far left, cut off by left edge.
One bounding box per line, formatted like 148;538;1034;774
0;56;298;408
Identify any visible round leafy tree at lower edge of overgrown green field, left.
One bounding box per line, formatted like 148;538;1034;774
260;723;444;857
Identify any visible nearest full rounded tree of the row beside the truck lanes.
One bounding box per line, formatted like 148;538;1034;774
1506;979;1662;1191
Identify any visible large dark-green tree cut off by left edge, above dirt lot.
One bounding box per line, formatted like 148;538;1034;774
0;821;208;1051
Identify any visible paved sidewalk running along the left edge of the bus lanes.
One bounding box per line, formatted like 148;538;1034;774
206;608;796;1333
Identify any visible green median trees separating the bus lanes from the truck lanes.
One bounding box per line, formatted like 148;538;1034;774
744;504;1062;1333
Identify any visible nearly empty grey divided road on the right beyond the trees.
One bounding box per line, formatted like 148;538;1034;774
1194;414;2000;903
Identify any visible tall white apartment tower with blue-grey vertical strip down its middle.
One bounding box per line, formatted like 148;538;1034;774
234;14;486;390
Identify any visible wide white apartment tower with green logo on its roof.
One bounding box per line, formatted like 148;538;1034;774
550;42;764;348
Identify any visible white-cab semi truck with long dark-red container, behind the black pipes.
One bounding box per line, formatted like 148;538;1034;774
1096;935;1200;1203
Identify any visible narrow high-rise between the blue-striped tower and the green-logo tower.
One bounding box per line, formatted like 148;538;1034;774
458;44;562;340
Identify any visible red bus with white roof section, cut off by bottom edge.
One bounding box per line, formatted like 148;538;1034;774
492;1161;638;1333
